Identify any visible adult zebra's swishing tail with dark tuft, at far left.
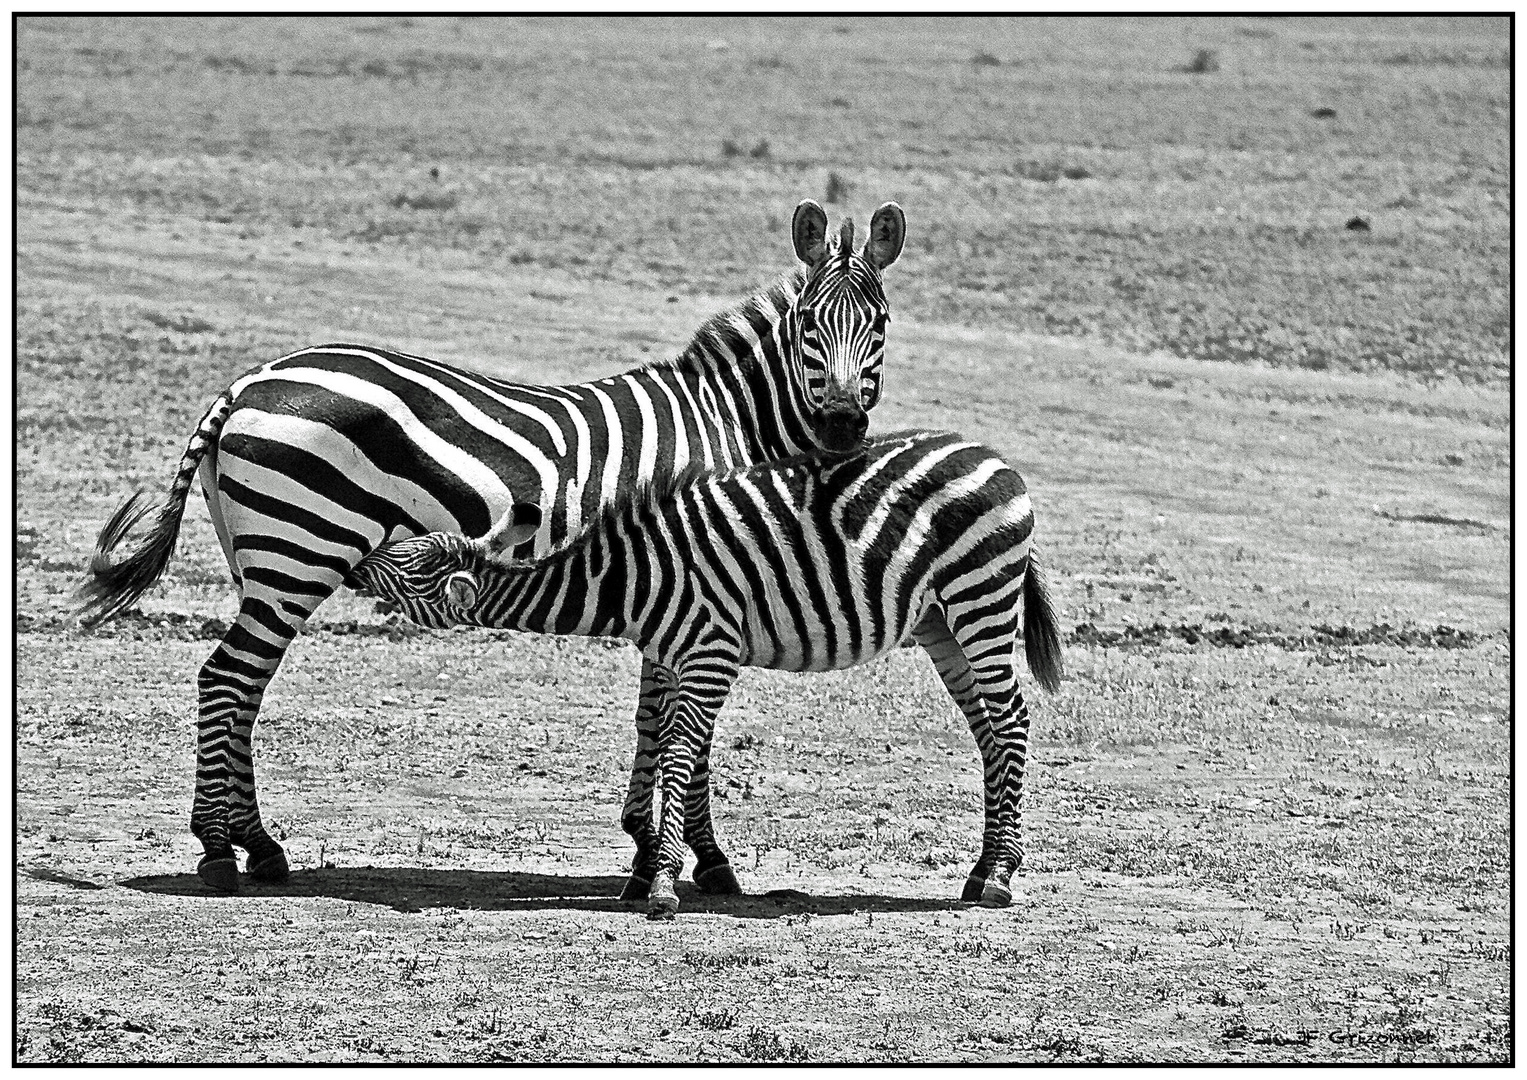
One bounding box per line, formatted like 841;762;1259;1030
75;391;234;626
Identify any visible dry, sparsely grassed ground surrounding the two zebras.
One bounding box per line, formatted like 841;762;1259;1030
15;20;1512;1062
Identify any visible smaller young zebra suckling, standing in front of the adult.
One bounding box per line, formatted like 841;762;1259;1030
354;432;1060;917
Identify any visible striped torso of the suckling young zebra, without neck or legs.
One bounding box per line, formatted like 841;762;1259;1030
670;431;1034;671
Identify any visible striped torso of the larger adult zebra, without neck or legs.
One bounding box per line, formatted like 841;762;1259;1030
217;344;744;550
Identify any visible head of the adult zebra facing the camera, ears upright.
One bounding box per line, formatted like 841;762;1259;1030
785;199;907;454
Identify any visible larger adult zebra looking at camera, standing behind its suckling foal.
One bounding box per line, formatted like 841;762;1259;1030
79;200;906;891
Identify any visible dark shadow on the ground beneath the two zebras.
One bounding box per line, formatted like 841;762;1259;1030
118;866;968;918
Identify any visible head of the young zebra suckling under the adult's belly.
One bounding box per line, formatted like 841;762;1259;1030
351;503;541;629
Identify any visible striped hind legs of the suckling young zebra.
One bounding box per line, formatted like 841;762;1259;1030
913;610;1029;907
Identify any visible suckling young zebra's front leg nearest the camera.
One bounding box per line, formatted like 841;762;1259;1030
647;642;738;918
